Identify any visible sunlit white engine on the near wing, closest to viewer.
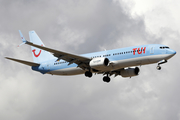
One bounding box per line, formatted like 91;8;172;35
89;58;109;70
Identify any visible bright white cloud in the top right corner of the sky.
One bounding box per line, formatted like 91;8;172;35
127;0;180;35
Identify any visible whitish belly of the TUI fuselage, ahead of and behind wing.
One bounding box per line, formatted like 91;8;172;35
48;54;170;75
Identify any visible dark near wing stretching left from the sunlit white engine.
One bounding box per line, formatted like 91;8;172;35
25;41;91;69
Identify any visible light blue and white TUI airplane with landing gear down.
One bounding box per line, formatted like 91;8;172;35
5;30;176;83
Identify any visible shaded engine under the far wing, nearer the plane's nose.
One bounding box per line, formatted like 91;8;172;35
121;67;140;77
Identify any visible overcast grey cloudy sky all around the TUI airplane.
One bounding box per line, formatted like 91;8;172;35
0;0;180;120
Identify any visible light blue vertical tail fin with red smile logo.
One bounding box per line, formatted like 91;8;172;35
29;31;55;63
